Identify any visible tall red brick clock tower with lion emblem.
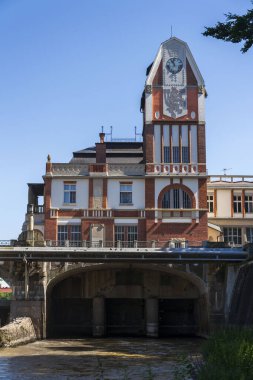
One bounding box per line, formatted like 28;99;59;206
142;37;207;241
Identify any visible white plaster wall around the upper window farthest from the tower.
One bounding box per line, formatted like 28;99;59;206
51;178;89;209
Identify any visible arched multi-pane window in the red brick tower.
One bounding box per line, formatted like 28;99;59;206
162;188;192;208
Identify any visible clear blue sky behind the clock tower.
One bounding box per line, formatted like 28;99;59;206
0;0;253;239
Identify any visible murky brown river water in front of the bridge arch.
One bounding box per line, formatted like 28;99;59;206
0;338;203;380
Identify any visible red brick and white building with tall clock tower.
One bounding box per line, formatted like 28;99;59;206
24;37;208;246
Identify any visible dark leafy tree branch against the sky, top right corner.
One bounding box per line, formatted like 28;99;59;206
202;1;253;53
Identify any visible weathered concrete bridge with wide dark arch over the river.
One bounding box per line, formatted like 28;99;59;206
0;241;249;338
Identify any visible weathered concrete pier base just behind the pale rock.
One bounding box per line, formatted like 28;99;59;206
10;300;44;339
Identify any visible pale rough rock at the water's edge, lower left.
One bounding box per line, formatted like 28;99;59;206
0;317;36;347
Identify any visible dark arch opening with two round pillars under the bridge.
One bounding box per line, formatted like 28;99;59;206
47;266;208;337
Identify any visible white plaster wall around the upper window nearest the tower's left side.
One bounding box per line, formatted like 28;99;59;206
107;179;145;210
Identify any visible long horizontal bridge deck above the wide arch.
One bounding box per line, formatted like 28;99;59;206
0;246;248;263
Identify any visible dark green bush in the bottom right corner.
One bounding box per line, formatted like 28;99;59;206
198;327;253;380
